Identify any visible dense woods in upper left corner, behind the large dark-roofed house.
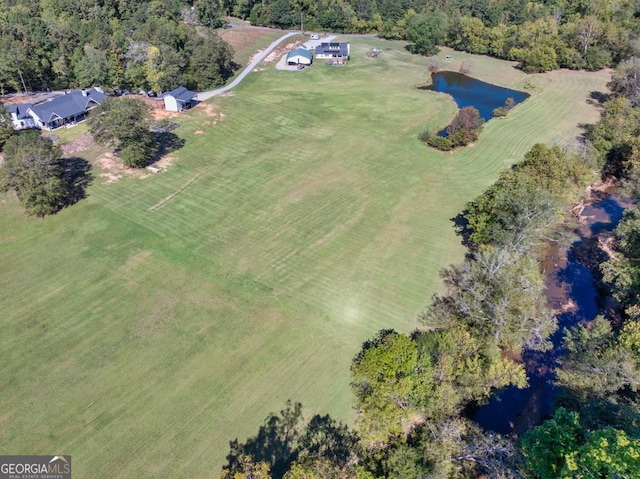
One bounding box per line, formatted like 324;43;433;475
0;0;236;92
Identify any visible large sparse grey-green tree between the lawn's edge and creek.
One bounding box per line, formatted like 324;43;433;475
428;248;557;351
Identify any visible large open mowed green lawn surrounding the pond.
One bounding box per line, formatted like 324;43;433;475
0;38;609;479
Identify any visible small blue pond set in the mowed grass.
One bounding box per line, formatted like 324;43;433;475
429;72;529;135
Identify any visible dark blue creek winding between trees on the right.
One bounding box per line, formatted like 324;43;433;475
469;194;628;436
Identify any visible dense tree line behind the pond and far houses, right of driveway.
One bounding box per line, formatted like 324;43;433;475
240;0;640;72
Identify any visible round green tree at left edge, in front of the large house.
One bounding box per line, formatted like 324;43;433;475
0;131;69;216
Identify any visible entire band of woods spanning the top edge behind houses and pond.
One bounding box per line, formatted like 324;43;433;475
0;0;640;92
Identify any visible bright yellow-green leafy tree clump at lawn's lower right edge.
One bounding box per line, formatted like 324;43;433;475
351;325;526;453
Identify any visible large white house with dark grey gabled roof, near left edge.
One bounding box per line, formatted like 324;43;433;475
26;88;106;130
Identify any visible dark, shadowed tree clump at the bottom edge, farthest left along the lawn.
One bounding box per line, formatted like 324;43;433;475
223;401;358;479
